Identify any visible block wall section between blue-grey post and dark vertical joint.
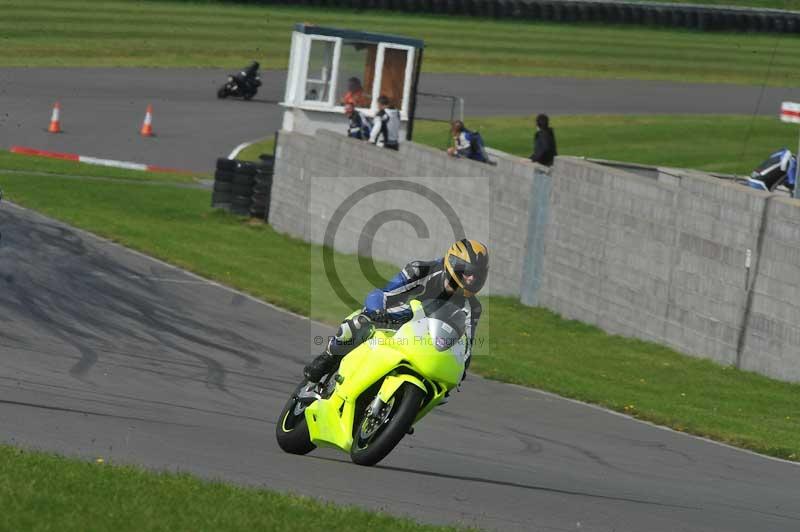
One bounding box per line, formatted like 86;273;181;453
523;158;767;364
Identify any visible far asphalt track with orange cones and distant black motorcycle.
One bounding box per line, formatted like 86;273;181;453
0;68;799;172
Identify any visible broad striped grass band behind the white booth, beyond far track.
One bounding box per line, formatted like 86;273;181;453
0;0;800;85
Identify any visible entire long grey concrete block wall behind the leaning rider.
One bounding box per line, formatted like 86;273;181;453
270;132;800;381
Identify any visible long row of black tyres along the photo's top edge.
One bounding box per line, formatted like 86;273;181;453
249;0;800;33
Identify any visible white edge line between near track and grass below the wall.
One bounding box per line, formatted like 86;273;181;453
4;202;800;467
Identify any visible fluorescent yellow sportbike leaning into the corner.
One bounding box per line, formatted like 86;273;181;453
276;300;467;466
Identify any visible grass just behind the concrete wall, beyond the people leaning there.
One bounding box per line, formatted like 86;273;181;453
240;115;798;175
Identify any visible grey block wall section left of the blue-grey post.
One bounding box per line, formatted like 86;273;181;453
269;131;538;296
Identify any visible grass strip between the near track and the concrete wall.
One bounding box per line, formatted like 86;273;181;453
0;168;800;460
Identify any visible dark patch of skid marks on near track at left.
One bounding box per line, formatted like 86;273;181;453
0;213;260;391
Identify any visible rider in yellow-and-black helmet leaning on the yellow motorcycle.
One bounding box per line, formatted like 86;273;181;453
303;238;489;382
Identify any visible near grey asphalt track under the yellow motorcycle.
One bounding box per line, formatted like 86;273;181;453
0;203;800;532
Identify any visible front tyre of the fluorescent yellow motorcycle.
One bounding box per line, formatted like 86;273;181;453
350;382;425;466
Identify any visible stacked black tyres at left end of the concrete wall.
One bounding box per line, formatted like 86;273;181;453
211;155;275;221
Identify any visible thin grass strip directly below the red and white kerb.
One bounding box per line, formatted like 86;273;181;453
0;150;210;183
